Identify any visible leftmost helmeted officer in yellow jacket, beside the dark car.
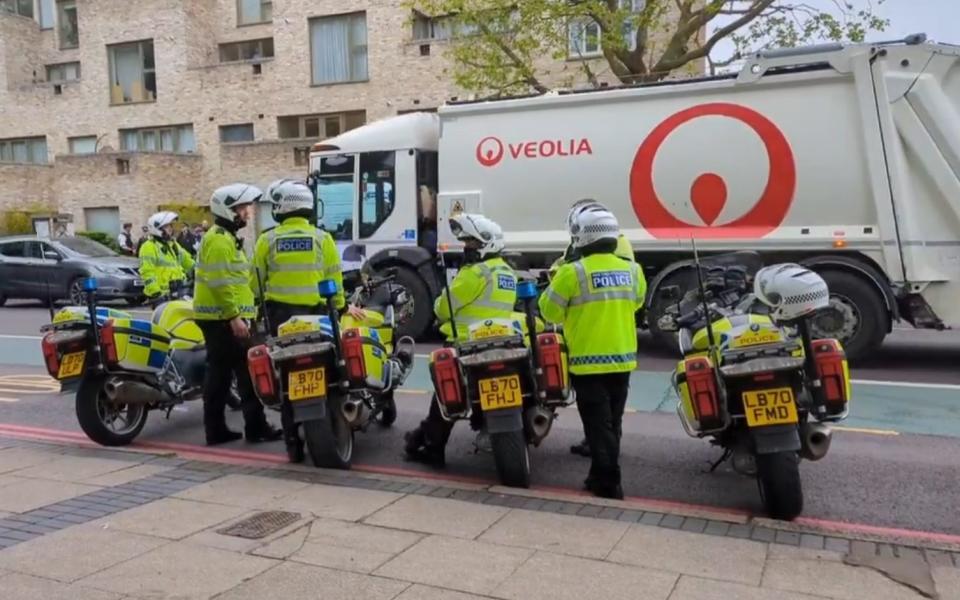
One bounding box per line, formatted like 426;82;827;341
138;211;194;300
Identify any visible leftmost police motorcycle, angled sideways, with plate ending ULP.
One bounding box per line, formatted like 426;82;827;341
41;278;239;446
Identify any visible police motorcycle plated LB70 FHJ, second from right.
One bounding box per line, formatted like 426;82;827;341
430;256;573;487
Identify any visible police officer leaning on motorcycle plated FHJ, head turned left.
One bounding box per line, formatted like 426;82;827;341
404;213;517;466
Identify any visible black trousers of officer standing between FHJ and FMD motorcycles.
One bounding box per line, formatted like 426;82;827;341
570;373;630;487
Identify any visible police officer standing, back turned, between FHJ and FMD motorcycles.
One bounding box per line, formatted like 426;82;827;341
539;206;647;499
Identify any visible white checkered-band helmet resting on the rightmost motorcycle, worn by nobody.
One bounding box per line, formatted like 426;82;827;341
753;263;830;321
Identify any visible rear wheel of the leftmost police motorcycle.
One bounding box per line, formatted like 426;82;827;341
76;377;148;446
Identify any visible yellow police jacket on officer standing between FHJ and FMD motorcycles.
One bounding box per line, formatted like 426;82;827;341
539;254;647;375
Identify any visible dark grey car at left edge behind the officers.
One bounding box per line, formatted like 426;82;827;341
0;236;143;306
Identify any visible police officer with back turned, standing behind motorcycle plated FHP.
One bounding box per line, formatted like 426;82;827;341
253;179;364;463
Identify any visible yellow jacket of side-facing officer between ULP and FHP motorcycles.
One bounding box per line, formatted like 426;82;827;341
193;225;257;321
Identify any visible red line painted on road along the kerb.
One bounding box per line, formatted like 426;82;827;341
0;423;960;544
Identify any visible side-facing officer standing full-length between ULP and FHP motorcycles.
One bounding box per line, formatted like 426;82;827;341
193;183;282;446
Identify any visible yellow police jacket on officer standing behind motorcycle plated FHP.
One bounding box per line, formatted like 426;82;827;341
251;217;346;308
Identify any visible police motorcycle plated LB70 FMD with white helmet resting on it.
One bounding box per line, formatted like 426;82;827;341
659;250;851;520
